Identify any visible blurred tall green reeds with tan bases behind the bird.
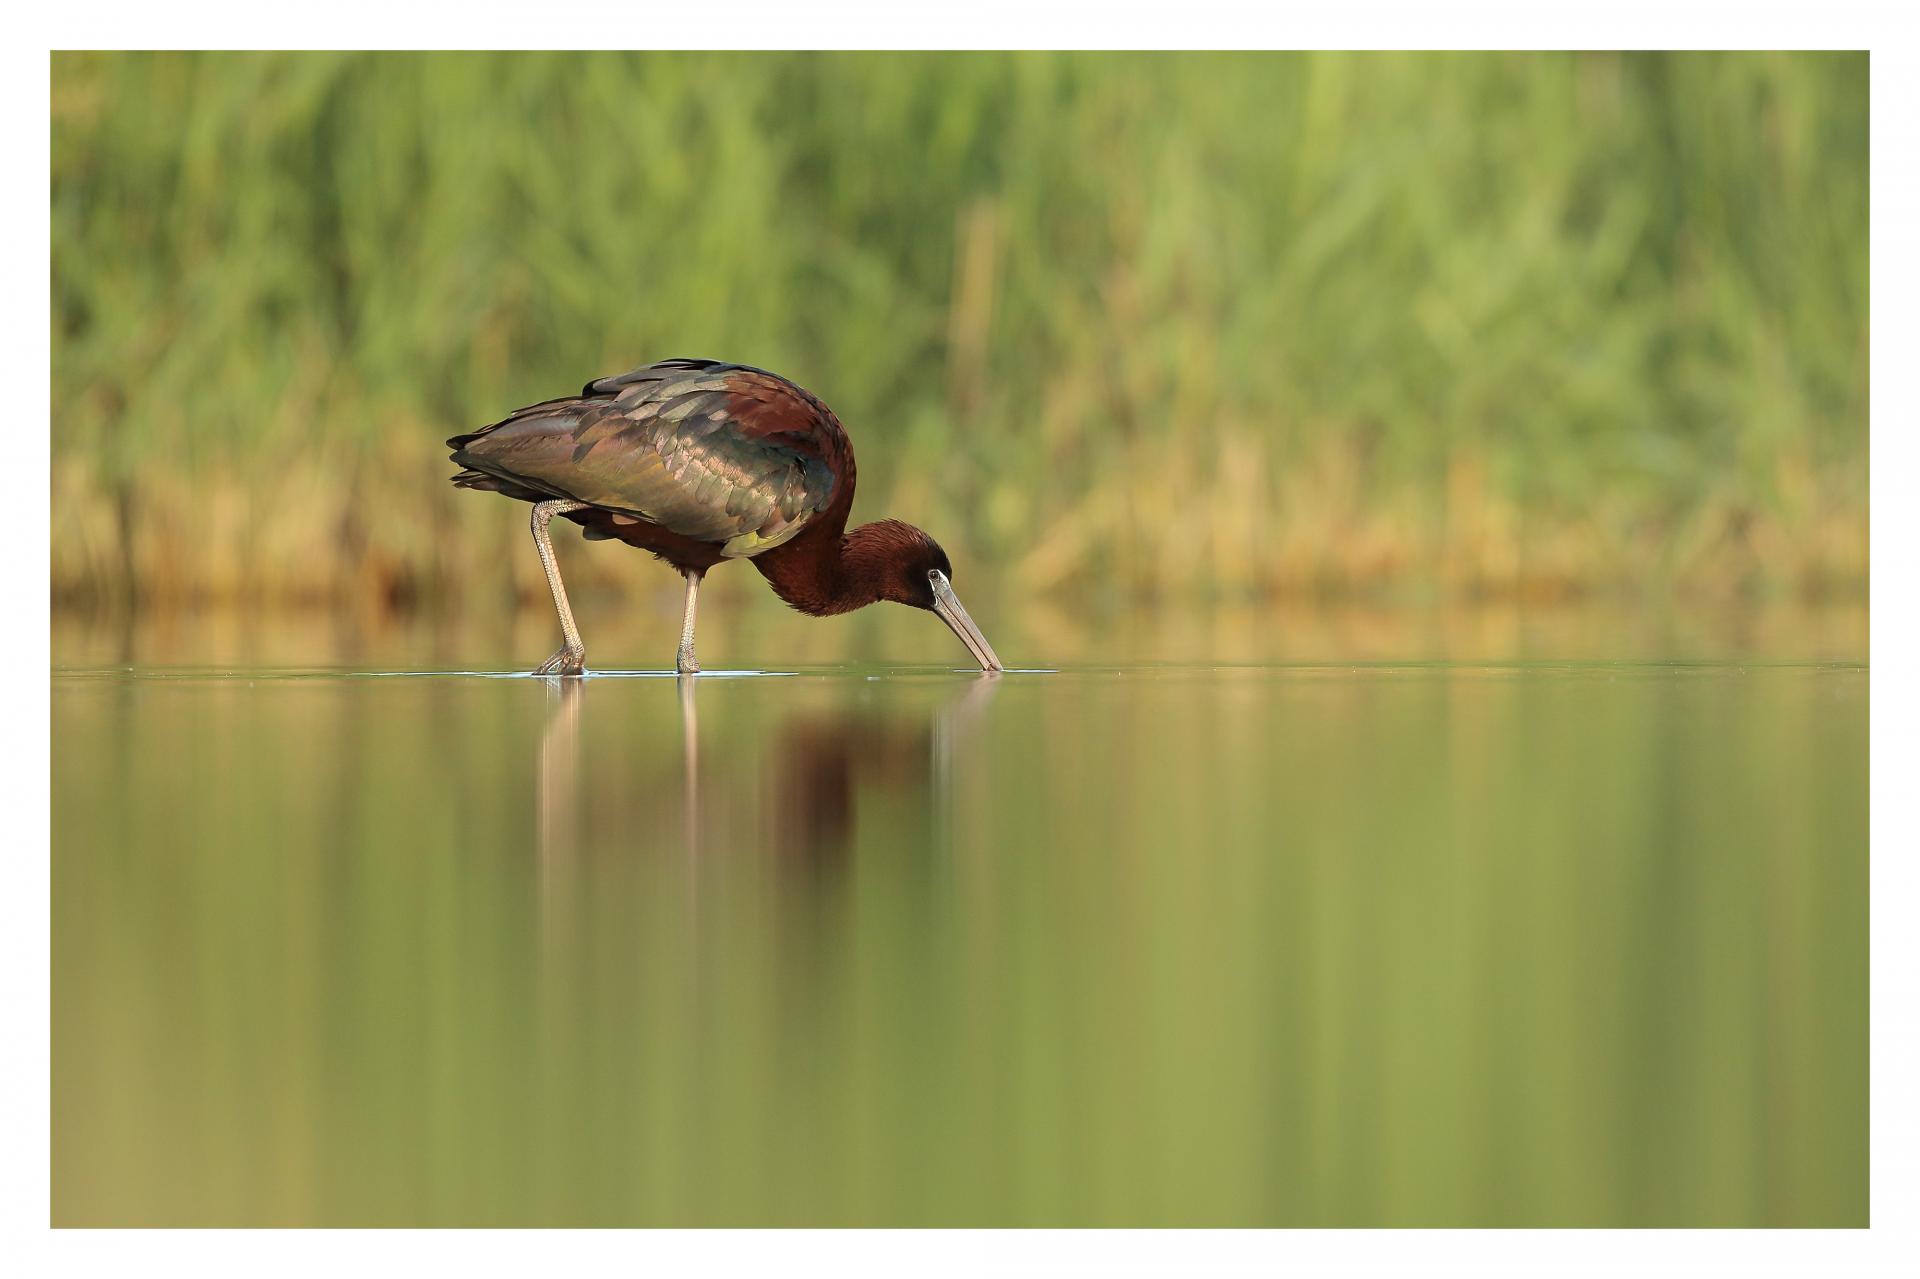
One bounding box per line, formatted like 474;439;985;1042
52;54;1868;601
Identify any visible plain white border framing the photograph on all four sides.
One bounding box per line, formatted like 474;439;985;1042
11;0;1920;1279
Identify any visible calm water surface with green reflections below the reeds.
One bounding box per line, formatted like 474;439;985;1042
52;609;1868;1225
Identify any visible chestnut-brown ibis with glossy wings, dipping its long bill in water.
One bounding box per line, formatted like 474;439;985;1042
447;359;1000;676
